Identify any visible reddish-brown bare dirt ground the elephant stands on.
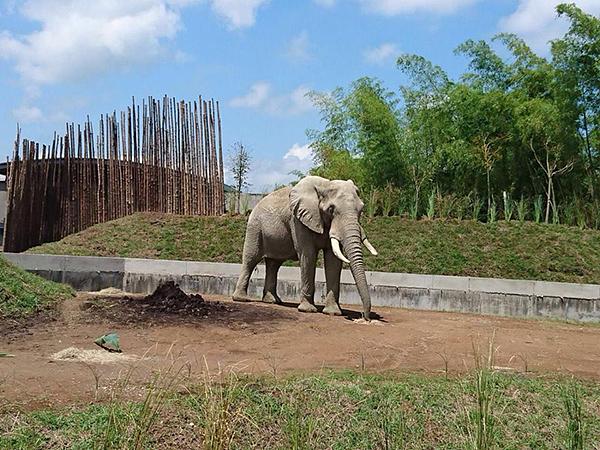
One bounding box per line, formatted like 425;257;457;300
0;294;600;408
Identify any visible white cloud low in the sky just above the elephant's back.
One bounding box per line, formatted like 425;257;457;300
250;144;313;192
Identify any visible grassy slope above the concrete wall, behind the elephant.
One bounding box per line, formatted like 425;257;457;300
29;214;600;283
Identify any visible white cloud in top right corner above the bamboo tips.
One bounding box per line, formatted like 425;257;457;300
499;0;600;53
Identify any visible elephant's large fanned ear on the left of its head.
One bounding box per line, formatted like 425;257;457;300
290;176;329;233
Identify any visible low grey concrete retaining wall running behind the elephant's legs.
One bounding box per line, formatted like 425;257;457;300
4;253;600;322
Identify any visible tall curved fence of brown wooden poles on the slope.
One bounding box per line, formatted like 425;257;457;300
4;96;225;252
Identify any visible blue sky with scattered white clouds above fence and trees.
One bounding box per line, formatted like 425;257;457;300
0;0;600;191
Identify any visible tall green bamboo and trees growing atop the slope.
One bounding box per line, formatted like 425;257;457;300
308;4;600;217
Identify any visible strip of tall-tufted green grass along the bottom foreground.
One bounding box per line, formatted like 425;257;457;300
0;371;600;450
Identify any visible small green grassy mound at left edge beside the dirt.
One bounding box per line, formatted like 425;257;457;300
0;256;73;320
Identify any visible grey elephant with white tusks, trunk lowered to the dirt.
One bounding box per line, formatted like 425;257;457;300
233;176;377;321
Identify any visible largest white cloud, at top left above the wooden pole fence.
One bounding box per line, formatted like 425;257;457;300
0;0;194;84
